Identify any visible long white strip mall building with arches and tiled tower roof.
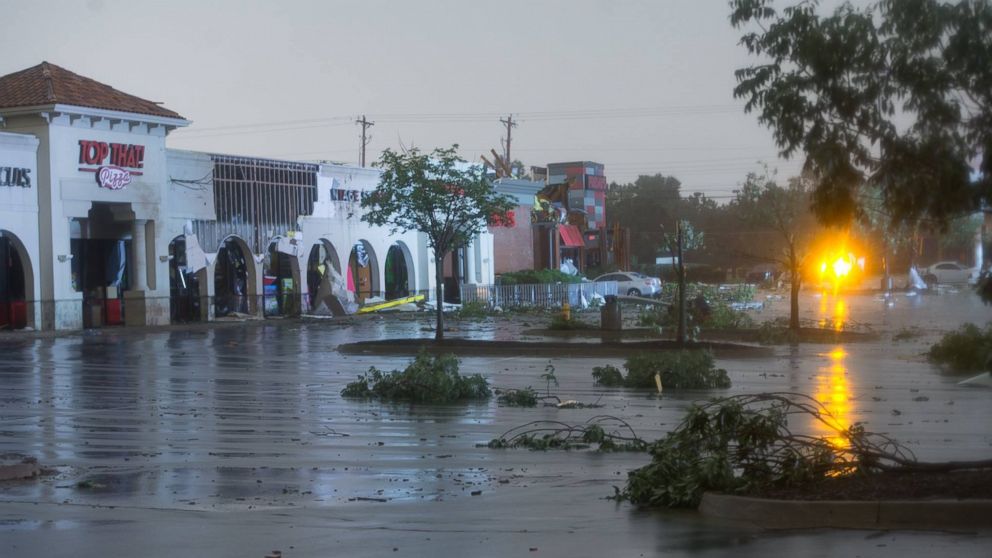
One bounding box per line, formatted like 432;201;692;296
0;63;496;330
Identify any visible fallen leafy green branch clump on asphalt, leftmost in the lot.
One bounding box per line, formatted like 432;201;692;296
341;351;492;403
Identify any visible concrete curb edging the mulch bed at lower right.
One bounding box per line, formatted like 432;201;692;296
699;492;992;530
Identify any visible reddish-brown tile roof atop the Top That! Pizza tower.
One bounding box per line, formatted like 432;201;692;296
0;62;182;118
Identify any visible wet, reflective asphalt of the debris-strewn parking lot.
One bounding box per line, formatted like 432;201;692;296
0;292;992;558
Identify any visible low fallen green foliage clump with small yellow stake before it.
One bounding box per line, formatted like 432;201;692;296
592;350;730;389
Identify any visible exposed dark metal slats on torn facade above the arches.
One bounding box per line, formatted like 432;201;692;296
194;155;318;254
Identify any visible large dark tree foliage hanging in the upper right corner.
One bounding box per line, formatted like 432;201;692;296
730;0;992;231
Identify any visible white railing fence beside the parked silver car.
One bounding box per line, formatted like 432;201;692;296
461;281;617;308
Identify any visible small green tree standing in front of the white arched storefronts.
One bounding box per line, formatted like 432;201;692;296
362;145;514;341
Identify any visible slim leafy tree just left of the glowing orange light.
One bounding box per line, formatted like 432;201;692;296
731;173;816;330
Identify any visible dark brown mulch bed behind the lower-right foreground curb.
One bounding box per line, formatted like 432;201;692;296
748;470;992;500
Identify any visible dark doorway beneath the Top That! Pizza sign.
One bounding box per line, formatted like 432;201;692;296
69;202;134;328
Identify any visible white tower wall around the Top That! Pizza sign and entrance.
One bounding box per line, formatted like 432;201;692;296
6;105;184;329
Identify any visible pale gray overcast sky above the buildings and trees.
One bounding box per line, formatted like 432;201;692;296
0;0;800;201
